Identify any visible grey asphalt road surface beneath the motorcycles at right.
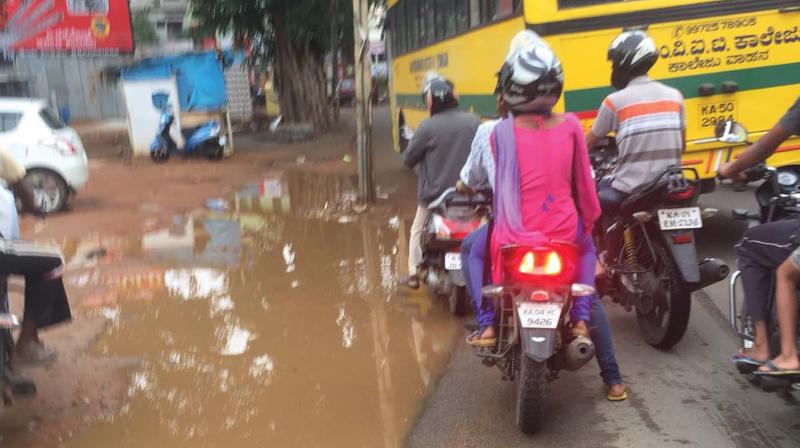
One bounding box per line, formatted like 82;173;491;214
409;182;800;448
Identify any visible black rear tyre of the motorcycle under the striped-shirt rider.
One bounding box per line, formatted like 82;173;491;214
636;243;692;350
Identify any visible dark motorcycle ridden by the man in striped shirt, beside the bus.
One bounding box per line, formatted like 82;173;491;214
590;138;729;349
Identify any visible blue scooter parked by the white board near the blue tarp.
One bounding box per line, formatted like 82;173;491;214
150;93;228;162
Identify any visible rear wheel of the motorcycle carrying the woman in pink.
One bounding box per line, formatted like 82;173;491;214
517;354;547;434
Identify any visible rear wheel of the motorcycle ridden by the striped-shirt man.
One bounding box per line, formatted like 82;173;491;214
636;242;692;350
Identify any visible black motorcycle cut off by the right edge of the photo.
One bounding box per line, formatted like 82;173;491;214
728;122;800;390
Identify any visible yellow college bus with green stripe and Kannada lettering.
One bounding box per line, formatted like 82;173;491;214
388;0;800;189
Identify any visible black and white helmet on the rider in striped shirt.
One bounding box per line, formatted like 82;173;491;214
608;31;658;90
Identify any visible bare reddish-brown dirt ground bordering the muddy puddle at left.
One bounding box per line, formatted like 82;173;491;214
0;112;406;446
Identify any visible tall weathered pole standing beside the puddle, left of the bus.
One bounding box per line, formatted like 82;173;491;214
353;0;375;203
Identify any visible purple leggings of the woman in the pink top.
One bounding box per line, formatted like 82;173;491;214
461;225;597;328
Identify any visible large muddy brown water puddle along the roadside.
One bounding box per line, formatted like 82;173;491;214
66;173;462;447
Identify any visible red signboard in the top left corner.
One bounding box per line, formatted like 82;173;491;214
0;0;133;55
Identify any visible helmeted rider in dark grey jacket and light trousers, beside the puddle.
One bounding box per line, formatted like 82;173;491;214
403;73;480;289
